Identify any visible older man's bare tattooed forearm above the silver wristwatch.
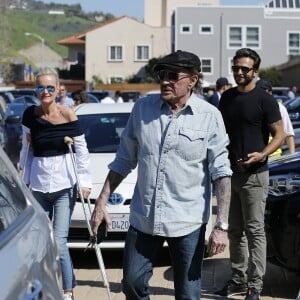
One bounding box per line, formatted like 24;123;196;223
214;177;231;223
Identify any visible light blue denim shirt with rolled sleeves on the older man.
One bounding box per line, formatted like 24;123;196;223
109;94;232;237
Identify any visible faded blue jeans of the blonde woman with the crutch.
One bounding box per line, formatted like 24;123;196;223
32;187;76;290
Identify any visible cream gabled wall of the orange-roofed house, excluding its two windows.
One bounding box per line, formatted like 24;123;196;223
85;17;170;83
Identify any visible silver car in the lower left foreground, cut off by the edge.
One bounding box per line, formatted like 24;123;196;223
0;149;63;300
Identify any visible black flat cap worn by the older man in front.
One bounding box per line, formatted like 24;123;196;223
153;50;201;72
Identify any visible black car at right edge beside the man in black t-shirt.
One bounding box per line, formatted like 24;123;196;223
265;152;300;271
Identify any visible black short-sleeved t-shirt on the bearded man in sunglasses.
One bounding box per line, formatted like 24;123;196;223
219;87;281;173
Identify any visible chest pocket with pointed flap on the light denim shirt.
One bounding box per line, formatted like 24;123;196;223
176;128;207;160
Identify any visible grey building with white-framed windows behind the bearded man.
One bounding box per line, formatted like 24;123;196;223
171;0;300;86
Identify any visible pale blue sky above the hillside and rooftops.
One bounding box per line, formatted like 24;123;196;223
43;0;268;21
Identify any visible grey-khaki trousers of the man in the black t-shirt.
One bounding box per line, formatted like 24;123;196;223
228;171;269;291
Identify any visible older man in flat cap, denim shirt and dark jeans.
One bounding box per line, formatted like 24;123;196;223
92;50;231;300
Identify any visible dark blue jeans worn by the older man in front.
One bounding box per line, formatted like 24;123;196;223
122;224;206;300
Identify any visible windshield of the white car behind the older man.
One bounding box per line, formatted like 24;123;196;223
78;113;130;153
